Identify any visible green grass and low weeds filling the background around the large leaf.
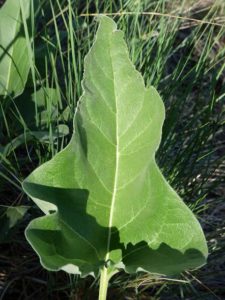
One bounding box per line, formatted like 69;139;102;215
0;0;225;300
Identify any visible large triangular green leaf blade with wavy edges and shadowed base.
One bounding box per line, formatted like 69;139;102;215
23;17;207;276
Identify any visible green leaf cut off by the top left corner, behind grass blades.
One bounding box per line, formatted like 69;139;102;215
0;0;30;97
